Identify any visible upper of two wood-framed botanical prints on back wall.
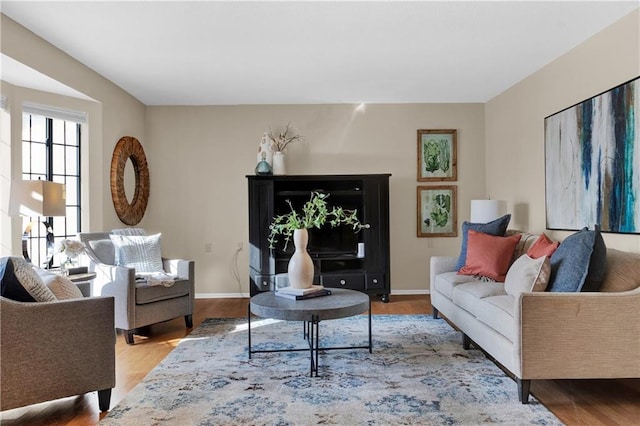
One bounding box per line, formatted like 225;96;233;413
418;129;458;182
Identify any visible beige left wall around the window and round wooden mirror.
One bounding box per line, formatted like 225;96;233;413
0;14;146;243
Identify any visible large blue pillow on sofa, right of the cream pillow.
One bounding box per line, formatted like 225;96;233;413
549;228;606;292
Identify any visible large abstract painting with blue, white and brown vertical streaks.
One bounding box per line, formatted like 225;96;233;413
544;77;640;234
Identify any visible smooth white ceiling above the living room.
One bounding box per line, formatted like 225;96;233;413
0;0;639;105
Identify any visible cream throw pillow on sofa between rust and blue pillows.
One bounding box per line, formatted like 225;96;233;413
504;254;551;296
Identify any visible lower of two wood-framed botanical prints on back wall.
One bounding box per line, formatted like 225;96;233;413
417;185;458;237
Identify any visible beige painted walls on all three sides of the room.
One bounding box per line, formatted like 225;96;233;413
0;9;640;295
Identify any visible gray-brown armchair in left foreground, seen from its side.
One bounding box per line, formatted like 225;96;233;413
0;297;116;411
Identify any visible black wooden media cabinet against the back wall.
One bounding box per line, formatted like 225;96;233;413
247;174;391;302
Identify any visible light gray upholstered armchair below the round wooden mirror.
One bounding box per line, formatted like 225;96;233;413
78;232;194;345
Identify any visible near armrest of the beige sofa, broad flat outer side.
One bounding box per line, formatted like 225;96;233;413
514;288;640;379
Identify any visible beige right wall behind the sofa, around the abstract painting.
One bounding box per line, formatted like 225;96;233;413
485;10;640;252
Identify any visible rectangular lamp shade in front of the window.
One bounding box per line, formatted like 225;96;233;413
9;180;66;217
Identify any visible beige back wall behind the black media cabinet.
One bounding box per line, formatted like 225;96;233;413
146;104;485;295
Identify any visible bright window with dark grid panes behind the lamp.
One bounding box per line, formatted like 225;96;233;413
22;106;82;267
